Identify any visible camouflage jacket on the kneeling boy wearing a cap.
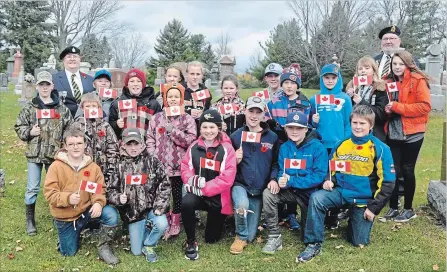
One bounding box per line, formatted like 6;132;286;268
107;148;171;223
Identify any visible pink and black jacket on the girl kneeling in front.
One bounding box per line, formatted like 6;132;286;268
181;133;237;215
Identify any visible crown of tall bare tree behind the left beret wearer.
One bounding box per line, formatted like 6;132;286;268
50;0;123;49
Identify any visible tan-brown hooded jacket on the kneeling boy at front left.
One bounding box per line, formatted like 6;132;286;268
44;149;106;221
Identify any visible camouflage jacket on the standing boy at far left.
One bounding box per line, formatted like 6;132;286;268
14;90;73;164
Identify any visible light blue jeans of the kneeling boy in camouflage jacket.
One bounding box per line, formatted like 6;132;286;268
129;210;168;255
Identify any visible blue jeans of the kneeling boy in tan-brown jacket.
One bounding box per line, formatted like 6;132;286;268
54;205;118;256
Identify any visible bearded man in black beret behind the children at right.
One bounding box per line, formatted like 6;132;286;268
374;25;404;78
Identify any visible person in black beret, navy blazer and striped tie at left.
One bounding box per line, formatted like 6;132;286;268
53;46;94;117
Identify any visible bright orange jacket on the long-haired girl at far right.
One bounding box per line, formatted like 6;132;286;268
385;69;431;135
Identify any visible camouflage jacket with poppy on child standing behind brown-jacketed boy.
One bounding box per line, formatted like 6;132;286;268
72;116;119;186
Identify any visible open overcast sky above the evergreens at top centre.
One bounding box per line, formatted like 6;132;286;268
117;1;293;73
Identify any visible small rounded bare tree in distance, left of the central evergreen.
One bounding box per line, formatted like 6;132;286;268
111;33;150;67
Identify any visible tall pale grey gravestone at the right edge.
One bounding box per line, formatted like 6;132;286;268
425;44;445;111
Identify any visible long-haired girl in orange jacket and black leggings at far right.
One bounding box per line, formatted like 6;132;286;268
385;51;431;222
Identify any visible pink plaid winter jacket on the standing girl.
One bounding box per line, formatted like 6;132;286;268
146;111;197;177
